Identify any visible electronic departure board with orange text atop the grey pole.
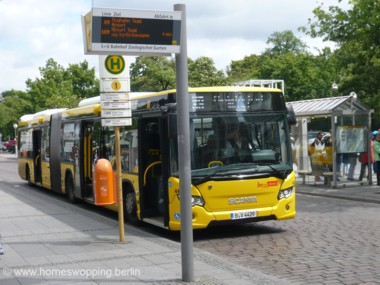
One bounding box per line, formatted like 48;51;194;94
85;8;181;55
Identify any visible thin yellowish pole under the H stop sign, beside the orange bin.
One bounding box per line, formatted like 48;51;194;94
114;127;124;242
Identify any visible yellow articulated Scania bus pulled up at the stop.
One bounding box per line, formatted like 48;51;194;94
17;86;296;231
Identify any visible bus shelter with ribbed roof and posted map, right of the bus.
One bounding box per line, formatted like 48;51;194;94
287;93;373;188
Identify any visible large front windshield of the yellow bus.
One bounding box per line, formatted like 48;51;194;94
172;112;292;177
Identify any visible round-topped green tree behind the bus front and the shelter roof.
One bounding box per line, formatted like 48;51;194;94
228;31;336;101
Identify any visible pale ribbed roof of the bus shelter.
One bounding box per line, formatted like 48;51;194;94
286;94;371;117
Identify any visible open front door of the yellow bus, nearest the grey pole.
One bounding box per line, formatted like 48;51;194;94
139;117;167;221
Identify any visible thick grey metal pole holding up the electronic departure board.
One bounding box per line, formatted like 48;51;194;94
174;4;194;282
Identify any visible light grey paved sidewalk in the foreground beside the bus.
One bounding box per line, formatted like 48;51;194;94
0;154;294;285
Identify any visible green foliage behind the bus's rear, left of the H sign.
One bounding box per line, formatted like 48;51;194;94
0;59;99;138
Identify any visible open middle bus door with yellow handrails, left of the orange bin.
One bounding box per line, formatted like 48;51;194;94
81;122;101;201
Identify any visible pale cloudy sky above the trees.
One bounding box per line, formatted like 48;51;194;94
0;0;348;93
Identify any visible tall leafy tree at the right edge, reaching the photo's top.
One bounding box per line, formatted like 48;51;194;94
301;0;380;119
